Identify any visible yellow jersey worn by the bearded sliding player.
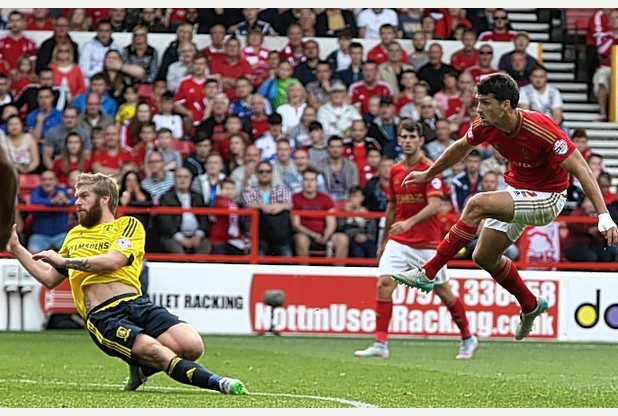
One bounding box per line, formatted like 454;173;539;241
59;216;146;318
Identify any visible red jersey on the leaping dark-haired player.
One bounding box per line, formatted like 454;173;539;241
466;109;576;192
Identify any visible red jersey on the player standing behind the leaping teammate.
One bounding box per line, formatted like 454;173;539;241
385;156;444;249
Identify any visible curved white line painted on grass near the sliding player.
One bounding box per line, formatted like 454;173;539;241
0;379;378;409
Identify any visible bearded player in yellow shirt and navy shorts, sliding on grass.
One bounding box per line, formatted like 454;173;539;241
7;173;248;394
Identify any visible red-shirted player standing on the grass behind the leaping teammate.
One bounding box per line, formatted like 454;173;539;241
354;121;478;359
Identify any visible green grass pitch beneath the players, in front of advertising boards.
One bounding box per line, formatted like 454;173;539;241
0;330;618;408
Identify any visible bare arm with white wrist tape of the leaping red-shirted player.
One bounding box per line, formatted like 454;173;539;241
560;152;618;246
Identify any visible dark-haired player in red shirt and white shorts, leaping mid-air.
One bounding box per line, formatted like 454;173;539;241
392;73;618;341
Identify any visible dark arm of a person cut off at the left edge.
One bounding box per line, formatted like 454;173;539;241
0;144;19;249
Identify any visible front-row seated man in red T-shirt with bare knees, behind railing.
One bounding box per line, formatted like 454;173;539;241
292;166;349;258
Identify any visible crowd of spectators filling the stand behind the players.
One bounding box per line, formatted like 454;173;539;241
0;8;618;261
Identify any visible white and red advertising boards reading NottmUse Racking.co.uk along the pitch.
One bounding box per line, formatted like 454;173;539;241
0;259;618;342
